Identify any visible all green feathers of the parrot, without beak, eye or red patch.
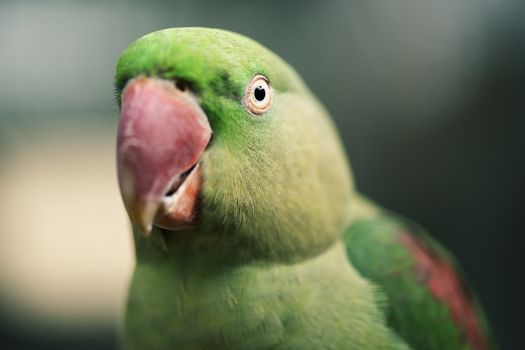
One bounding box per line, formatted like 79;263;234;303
116;28;496;349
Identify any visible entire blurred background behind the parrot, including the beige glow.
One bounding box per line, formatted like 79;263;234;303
0;0;525;349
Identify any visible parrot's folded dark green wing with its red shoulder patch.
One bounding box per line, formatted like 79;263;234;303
344;211;495;350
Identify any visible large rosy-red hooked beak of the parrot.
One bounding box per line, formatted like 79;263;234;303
117;78;212;235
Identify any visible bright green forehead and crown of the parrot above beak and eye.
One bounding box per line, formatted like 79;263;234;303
116;27;302;95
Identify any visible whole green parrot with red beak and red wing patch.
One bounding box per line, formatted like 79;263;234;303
115;28;495;350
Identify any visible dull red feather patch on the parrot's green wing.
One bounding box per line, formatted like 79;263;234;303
400;233;489;350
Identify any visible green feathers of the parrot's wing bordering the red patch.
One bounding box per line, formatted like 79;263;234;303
345;212;494;349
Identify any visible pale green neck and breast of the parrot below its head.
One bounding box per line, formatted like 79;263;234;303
126;242;398;348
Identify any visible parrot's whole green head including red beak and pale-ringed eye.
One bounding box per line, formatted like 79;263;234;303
115;28;353;260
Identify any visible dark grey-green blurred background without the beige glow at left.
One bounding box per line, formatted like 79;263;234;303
0;0;525;349
